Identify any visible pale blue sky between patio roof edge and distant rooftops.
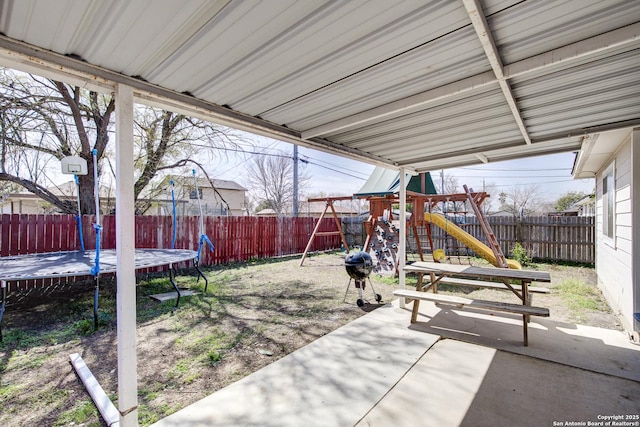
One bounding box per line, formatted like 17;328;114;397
208;136;595;201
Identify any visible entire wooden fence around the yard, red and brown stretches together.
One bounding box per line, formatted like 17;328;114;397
0;214;595;288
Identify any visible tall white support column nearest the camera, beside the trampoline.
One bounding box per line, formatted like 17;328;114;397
115;84;138;427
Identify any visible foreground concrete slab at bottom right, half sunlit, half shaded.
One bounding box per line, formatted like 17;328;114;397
357;339;640;427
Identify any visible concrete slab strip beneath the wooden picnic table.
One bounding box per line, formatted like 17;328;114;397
404;301;640;381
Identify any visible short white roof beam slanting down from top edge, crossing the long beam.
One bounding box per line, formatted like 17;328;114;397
462;0;531;144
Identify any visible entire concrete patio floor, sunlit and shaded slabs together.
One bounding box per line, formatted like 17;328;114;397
154;301;640;427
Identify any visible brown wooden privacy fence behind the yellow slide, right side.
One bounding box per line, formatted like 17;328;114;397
343;216;595;264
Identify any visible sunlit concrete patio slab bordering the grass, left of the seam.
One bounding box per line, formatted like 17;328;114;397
154;305;439;427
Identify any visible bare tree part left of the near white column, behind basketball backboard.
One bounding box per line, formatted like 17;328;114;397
0;69;115;213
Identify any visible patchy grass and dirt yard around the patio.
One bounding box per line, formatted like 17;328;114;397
0;253;619;426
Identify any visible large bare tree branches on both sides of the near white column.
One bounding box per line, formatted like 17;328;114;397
0;68;237;213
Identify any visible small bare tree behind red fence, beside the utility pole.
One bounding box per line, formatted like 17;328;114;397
247;155;310;216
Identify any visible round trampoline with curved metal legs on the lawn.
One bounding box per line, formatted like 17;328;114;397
0;249;208;340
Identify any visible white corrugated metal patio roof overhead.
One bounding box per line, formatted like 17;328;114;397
0;0;640;171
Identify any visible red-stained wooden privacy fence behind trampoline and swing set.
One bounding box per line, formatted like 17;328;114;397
0;214;341;290
